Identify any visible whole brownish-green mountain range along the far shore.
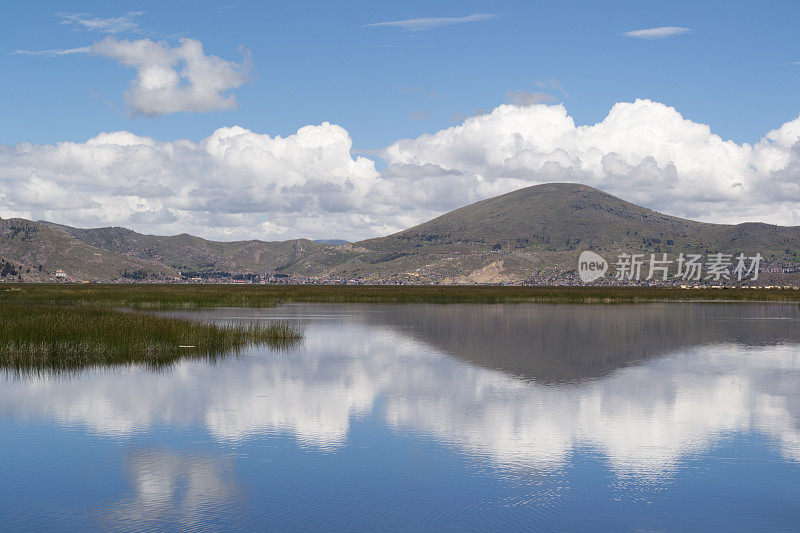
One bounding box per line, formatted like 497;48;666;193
0;183;800;283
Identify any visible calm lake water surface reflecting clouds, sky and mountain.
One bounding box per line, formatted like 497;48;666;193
0;304;800;531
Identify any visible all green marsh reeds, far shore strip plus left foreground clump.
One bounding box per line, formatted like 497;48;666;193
0;284;800;370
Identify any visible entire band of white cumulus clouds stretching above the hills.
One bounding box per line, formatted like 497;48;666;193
0;100;800;240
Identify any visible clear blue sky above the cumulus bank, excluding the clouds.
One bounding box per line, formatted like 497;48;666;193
6;1;800;149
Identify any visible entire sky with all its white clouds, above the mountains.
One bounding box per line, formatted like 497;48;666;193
0;1;800;240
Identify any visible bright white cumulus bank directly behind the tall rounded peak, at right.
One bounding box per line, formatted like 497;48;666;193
383;100;800;224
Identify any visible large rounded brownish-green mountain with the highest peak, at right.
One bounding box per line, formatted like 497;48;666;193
322;183;800;283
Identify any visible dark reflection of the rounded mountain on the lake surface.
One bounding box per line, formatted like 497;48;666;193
356;303;800;383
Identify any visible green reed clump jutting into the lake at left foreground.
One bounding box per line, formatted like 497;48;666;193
0;302;302;370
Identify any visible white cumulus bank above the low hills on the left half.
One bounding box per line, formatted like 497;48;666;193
0;123;394;238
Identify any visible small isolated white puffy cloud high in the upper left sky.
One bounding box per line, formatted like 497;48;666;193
91;37;251;116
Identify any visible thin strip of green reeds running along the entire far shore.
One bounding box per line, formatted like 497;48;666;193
0;284;800;309
